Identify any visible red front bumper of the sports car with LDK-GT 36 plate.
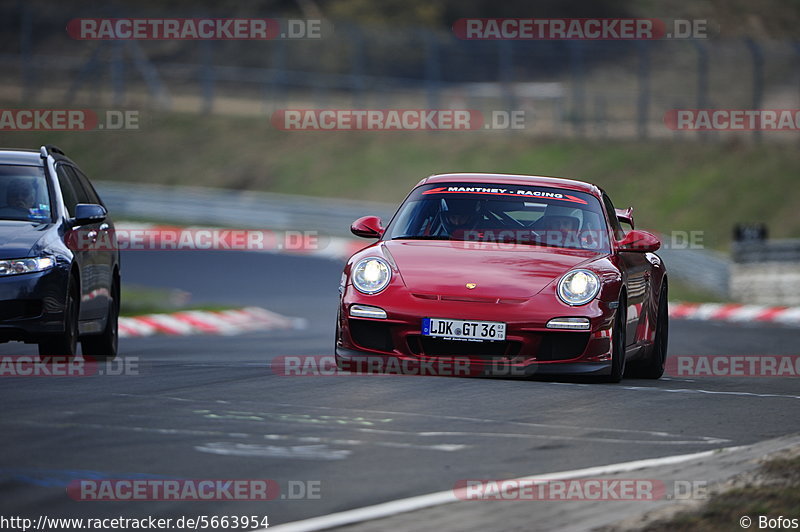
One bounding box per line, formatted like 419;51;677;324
336;287;615;376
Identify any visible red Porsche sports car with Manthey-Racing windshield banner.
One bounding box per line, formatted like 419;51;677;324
336;174;668;382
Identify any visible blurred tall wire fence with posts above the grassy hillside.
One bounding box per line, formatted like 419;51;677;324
0;2;800;140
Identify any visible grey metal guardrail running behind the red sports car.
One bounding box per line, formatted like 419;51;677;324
95;182;730;296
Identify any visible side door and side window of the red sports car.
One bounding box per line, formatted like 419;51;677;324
603;193;652;345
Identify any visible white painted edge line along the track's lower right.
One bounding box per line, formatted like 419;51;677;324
260;447;739;532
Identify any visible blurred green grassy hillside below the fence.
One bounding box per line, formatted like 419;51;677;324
0;110;800;248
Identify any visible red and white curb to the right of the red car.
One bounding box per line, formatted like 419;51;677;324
669;303;800;326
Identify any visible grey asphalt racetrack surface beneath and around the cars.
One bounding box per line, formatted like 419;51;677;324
0;251;800;526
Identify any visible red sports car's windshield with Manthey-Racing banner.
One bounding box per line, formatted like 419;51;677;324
385;183;609;251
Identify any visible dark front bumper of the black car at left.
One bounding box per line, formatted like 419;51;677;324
0;266;69;343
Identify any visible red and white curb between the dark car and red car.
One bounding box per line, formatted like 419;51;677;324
119;307;306;338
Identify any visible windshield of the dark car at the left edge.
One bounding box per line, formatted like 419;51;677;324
0;165;51;222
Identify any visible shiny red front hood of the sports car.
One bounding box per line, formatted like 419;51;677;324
384;240;606;299
